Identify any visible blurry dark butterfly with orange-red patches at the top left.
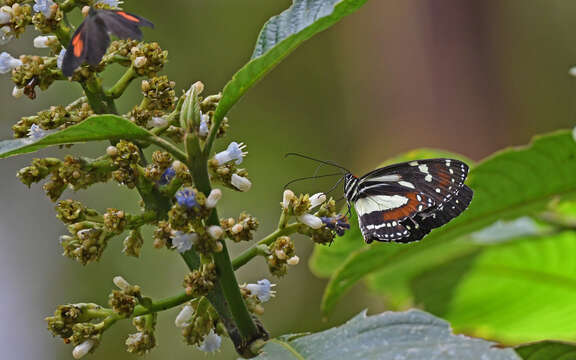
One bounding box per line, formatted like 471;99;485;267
62;8;154;77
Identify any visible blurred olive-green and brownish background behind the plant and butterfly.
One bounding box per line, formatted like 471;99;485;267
0;0;576;360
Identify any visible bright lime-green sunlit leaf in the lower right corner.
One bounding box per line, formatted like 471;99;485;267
414;231;576;344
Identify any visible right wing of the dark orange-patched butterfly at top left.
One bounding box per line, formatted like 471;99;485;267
96;10;154;40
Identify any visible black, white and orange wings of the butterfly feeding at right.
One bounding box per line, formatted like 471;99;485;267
355;159;473;243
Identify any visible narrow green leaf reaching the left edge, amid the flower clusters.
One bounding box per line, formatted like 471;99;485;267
0;115;153;159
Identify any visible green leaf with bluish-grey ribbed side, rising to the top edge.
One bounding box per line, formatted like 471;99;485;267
214;0;367;122
